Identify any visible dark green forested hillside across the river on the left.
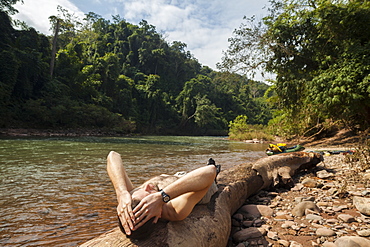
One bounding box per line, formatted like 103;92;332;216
0;5;271;134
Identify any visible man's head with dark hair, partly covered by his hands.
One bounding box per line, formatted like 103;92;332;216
118;184;158;239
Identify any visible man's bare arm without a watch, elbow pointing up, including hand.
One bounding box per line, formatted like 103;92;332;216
107;151;135;235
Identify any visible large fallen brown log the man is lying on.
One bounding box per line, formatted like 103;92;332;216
81;152;323;247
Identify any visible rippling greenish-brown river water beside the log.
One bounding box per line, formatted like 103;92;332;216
0;136;266;246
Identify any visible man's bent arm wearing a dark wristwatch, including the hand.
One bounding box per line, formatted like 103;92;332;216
134;165;217;229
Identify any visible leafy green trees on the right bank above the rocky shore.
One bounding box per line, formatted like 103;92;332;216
220;0;370;136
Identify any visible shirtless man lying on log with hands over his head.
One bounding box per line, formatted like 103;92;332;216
107;151;220;239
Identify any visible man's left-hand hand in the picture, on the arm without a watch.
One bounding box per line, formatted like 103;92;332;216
117;191;135;235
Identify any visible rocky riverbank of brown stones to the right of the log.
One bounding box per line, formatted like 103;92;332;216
228;150;370;247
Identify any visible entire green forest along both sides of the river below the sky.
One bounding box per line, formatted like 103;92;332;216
0;0;370;138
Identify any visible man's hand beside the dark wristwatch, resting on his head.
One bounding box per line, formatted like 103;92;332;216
134;192;164;230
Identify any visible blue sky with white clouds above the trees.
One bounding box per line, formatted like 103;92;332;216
13;0;268;80
